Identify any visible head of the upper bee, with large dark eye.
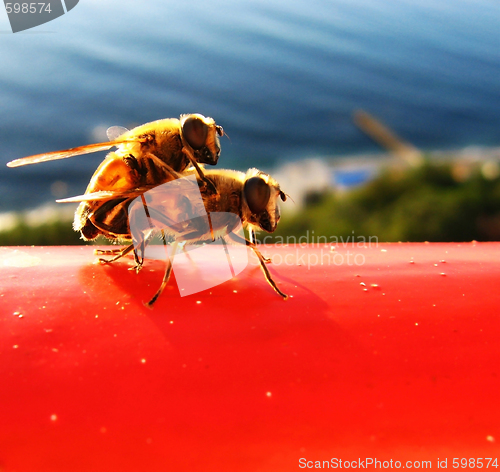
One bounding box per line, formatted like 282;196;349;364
181;113;224;165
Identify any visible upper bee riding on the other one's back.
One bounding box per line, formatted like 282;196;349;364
7;114;224;241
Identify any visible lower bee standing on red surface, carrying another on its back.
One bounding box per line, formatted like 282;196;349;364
59;169;288;307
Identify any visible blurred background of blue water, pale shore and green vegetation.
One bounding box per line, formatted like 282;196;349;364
0;0;500;245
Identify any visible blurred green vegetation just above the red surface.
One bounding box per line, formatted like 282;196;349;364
0;162;500;246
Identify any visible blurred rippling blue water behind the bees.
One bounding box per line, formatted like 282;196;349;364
0;0;500;211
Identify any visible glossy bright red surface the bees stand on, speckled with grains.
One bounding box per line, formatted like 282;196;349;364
0;243;500;472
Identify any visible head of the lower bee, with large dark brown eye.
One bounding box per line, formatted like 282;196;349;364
243;169;286;233
